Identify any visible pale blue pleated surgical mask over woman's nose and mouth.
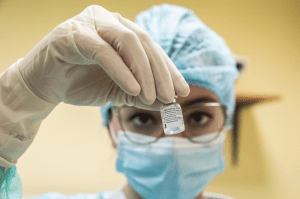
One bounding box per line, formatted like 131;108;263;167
110;125;226;199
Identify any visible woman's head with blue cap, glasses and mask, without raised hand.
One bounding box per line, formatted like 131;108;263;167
95;5;237;199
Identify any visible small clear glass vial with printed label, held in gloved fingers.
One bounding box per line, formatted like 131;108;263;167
160;96;185;135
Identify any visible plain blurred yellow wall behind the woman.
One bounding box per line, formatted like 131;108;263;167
0;0;300;199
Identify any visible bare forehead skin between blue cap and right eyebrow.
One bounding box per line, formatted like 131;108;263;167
176;85;220;105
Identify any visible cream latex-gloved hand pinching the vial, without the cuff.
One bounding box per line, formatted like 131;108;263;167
18;5;189;110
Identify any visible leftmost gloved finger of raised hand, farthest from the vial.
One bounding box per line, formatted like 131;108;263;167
72;9;141;96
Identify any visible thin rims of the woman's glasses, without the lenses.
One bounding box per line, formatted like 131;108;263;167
112;102;229;145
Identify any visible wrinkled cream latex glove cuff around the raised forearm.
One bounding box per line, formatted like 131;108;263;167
0;59;58;167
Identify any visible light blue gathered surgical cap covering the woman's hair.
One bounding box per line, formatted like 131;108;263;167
101;4;238;130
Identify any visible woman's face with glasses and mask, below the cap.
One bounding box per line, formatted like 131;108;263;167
100;85;228;199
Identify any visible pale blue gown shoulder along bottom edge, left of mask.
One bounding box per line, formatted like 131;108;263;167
35;191;112;199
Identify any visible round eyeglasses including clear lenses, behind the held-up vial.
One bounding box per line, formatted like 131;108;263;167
113;102;227;145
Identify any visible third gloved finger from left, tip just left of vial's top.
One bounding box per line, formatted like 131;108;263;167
115;14;175;103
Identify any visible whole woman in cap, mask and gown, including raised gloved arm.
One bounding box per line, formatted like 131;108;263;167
0;4;238;199
